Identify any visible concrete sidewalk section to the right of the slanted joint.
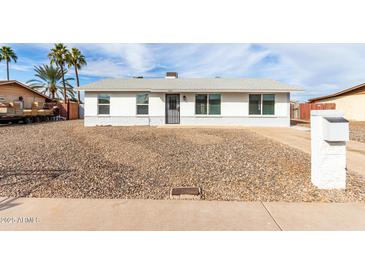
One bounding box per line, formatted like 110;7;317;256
264;202;365;230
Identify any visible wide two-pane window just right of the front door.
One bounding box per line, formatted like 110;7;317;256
195;93;221;115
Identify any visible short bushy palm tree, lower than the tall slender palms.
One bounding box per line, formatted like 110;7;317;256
27;65;75;99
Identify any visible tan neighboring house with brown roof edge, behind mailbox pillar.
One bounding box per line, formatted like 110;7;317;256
308;83;365;121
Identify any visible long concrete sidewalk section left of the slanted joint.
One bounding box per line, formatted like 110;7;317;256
0;198;278;230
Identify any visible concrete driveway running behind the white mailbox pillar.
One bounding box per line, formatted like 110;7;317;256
250;127;365;177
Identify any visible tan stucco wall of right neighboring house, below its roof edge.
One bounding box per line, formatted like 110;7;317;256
315;94;365;121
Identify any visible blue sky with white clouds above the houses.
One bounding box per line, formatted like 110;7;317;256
0;43;365;101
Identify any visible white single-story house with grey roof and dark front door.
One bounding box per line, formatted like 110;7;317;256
79;73;300;127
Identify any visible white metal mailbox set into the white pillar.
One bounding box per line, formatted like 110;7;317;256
323;117;349;142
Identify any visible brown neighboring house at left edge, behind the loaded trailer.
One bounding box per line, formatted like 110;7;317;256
0;80;51;109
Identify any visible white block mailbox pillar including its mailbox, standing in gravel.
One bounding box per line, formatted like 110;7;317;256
311;110;349;189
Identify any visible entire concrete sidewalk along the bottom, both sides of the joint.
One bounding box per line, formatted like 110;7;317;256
0;198;365;230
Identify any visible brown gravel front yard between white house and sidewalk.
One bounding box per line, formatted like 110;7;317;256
0;121;365;202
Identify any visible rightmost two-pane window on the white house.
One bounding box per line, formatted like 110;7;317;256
249;94;275;115
